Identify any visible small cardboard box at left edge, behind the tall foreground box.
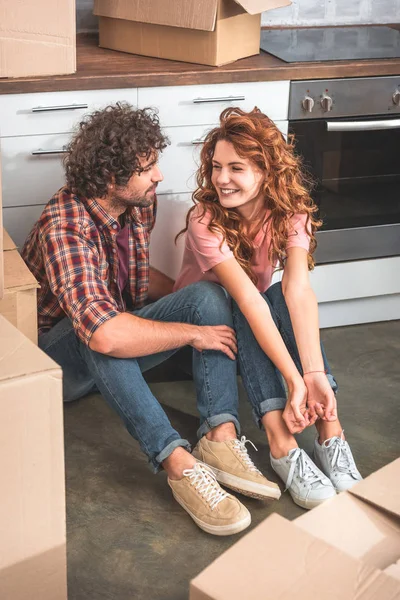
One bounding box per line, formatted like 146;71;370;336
0;229;39;344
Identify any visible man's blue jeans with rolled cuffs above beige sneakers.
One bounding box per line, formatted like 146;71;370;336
39;282;240;472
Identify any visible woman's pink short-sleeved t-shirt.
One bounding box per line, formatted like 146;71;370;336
174;209;310;292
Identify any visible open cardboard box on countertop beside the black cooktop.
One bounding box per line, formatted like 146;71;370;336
93;0;291;66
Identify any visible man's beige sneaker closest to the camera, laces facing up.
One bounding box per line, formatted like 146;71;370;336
168;463;251;535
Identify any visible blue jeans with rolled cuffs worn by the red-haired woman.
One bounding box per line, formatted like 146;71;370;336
232;282;338;428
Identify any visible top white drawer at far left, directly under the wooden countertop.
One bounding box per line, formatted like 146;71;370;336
0;88;137;137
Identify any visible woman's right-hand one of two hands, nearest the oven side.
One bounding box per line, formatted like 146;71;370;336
303;372;337;424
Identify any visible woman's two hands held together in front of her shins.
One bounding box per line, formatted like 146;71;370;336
282;372;337;433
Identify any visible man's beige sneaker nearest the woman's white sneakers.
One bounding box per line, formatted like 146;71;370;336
193;436;281;500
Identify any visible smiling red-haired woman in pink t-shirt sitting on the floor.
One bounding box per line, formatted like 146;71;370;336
175;108;361;508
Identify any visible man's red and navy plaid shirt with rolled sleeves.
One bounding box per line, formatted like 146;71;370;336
22;187;156;344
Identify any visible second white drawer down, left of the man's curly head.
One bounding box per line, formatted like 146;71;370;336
1;134;70;207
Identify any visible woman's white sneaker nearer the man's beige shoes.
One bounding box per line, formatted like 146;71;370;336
270;448;336;509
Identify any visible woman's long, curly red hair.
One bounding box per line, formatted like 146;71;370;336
177;107;321;283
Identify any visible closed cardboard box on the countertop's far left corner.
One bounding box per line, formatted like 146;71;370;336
0;0;76;77
